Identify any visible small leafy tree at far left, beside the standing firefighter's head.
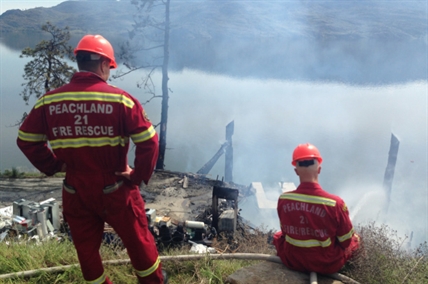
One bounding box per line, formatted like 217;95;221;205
19;22;76;104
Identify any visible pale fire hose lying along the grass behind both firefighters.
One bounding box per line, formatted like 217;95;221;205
0;253;360;284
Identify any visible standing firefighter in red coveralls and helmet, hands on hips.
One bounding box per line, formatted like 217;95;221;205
17;35;164;284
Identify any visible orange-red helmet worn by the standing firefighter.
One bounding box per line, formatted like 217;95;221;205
74;35;117;69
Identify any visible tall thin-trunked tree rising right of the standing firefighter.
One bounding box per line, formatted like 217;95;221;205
117;0;170;169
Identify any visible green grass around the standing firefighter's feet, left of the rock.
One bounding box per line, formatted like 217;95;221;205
0;239;260;284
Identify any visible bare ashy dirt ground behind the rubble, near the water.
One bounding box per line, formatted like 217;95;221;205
0;171;244;221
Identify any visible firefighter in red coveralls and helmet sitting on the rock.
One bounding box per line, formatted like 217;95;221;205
273;144;360;274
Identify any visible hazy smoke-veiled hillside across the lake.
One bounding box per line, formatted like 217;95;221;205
0;0;428;84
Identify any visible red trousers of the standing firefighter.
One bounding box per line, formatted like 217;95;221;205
63;173;163;284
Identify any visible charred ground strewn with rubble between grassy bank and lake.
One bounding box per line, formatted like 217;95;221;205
0;171;254;251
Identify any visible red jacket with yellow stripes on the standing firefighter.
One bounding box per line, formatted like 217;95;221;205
17;72;158;185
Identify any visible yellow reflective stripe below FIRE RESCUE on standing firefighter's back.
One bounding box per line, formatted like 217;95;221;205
49;136;129;149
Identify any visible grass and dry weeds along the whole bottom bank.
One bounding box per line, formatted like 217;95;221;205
0;223;428;284
